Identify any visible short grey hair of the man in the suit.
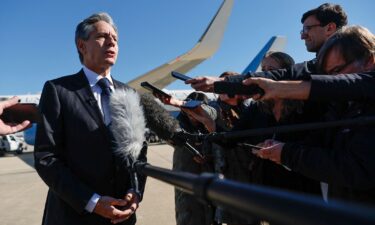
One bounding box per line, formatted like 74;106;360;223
75;12;117;63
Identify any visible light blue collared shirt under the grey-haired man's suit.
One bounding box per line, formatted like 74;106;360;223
83;66;115;125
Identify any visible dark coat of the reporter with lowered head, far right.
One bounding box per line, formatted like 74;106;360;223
281;99;375;204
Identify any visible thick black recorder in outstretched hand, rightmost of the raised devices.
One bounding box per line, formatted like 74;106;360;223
214;81;264;98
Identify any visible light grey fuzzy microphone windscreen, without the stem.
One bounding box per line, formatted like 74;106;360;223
109;88;146;160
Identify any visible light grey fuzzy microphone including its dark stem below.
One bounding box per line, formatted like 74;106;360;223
109;89;146;197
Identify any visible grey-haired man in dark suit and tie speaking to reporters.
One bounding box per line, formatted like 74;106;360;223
34;13;146;225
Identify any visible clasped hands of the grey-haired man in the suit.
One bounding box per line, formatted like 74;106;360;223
94;196;129;220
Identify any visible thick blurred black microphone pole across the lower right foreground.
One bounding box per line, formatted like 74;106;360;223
134;162;375;225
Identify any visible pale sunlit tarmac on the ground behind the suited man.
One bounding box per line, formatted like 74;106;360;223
0;144;176;225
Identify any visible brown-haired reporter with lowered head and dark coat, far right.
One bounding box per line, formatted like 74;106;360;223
254;26;375;204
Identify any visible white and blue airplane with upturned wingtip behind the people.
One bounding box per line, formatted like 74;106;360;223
0;0;286;145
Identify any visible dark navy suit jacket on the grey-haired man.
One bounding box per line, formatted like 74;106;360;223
34;70;146;225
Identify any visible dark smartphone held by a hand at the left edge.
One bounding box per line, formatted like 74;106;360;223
0;103;40;124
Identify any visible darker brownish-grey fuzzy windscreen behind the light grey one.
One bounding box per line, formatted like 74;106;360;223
141;93;180;140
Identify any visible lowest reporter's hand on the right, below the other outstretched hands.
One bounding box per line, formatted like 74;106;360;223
252;139;285;164
